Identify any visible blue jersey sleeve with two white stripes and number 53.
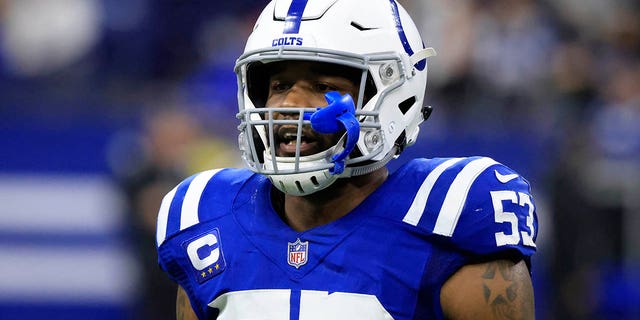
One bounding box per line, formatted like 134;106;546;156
405;157;538;261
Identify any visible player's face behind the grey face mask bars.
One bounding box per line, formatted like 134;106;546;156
266;61;358;157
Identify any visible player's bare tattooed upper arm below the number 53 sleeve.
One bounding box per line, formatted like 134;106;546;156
440;260;534;320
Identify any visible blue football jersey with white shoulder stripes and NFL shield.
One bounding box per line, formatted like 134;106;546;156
157;157;538;320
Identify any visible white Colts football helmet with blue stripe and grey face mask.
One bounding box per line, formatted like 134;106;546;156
235;0;435;195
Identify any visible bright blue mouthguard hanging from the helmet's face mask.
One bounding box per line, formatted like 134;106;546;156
304;91;360;175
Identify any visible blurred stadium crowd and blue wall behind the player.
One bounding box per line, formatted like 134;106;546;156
0;0;640;320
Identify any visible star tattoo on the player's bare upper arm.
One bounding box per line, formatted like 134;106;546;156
482;260;533;319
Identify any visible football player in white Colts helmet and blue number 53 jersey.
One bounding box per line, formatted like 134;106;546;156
157;0;538;320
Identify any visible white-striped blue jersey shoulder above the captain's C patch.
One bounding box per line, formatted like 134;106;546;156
156;169;252;247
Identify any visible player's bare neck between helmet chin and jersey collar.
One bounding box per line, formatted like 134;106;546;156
274;168;388;232
